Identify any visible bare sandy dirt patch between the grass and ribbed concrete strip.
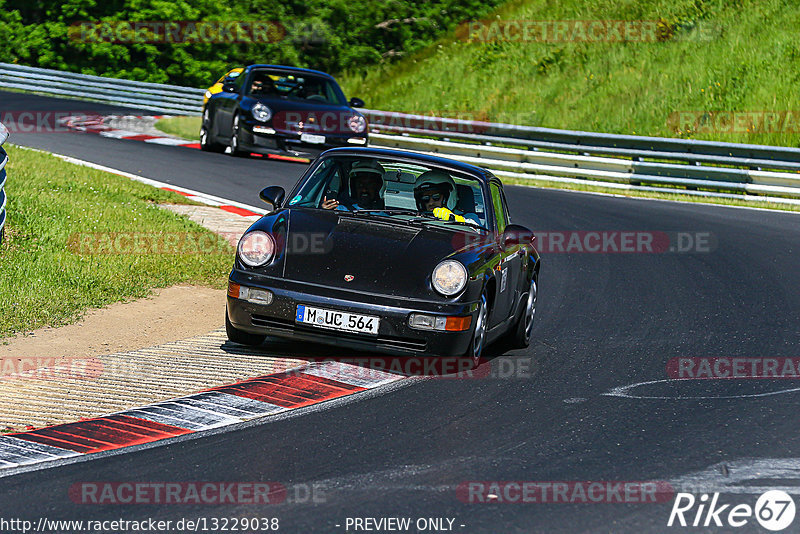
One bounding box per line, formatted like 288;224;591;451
0;286;225;358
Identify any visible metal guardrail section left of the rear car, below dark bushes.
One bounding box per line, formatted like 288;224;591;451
0;63;205;115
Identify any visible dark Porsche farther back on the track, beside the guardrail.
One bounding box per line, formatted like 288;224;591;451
200;65;368;156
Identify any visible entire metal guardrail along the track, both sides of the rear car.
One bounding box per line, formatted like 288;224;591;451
0;63;800;203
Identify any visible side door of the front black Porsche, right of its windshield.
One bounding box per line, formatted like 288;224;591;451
489;182;522;326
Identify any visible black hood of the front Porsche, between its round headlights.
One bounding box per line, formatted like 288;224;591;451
272;209;466;297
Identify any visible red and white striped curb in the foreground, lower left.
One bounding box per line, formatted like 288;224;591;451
0;362;407;470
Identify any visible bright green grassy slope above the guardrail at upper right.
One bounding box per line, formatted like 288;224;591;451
338;0;800;146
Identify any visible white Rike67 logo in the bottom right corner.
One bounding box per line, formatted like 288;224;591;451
667;490;795;532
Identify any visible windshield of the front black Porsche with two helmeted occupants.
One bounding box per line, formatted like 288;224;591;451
289;156;489;228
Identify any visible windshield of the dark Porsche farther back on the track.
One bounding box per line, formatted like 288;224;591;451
247;69;345;106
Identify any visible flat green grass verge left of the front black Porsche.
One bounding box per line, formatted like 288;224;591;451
0;145;233;337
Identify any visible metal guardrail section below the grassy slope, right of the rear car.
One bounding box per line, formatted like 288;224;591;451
365;110;800;203
